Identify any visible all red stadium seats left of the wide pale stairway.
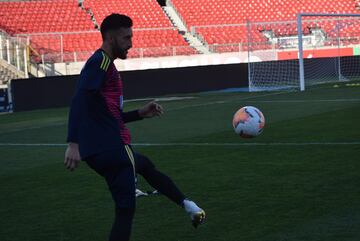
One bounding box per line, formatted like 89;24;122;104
0;0;197;62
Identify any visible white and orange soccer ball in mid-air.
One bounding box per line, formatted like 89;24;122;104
233;106;265;138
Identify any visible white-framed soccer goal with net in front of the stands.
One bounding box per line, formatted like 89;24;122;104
247;13;360;91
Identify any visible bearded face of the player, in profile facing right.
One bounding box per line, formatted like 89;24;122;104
111;28;133;59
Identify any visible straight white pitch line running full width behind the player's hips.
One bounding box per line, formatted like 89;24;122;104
0;141;360;147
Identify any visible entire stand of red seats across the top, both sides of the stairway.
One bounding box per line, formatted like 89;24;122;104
0;0;360;62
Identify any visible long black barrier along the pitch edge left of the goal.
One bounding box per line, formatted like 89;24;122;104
11;64;248;112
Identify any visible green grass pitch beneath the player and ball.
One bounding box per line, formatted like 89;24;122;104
0;84;360;241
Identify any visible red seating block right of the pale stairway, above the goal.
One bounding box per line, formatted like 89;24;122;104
171;0;360;52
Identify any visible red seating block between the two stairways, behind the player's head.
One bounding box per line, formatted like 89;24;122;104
80;0;197;57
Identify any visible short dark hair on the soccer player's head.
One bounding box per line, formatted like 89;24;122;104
100;13;133;40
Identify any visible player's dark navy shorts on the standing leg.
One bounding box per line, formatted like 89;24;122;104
84;145;136;208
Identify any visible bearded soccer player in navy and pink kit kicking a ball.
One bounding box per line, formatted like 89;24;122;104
64;14;205;241
